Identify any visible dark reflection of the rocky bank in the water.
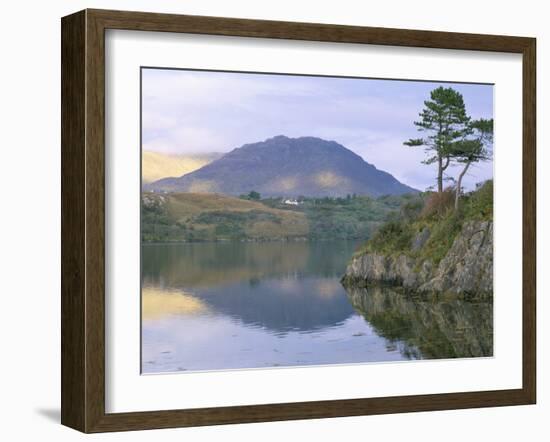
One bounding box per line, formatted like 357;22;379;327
346;287;493;359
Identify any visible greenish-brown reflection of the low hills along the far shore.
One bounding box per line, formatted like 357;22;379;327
142;241;356;288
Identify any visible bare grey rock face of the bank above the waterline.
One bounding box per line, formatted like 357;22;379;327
342;221;493;295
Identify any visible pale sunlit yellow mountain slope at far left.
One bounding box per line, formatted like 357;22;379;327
141;151;222;184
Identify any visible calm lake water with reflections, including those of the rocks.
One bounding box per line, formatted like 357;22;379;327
142;241;493;373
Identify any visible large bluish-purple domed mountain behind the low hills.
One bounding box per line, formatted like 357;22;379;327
147;135;416;197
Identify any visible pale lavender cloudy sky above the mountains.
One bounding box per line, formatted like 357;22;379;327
142;68;493;190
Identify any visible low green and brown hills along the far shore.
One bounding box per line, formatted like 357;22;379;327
142;193;415;242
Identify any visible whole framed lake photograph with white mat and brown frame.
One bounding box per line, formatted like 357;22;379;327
61;10;536;432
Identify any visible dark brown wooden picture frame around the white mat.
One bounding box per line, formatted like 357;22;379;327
61;10;536;432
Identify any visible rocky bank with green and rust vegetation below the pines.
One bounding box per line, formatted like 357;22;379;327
342;180;493;299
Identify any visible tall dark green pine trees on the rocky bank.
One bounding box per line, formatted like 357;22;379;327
404;87;493;209
